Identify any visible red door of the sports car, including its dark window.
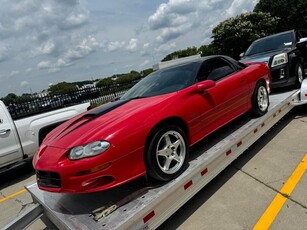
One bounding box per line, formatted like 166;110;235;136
198;57;249;135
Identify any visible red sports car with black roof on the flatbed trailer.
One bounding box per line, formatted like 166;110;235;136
33;56;271;193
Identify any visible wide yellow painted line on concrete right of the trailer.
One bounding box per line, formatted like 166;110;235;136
254;154;307;230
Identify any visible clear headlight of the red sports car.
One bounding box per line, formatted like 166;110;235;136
69;141;110;160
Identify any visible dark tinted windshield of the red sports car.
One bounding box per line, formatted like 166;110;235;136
121;62;199;100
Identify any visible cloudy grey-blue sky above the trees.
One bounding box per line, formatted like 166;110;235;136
0;0;259;97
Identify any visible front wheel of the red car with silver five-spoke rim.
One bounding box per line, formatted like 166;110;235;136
145;125;189;181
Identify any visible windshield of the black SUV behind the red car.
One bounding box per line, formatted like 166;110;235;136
244;32;293;56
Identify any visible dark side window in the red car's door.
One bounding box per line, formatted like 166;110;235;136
197;58;235;81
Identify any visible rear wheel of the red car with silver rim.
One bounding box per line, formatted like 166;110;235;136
252;82;269;116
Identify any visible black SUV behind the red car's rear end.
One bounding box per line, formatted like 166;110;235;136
241;30;307;88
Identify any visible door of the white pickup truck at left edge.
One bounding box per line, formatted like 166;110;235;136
0;104;23;167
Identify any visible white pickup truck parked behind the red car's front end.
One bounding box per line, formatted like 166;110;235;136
0;101;90;172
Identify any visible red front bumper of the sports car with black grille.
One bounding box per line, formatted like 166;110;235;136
33;146;145;193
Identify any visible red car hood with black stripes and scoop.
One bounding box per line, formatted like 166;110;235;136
43;93;176;148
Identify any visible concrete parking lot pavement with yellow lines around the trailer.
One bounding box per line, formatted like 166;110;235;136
0;106;307;229
